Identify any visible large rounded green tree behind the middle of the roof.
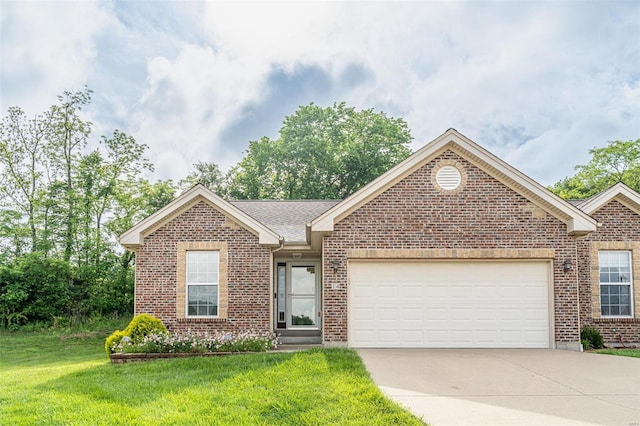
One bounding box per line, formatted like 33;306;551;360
227;102;412;199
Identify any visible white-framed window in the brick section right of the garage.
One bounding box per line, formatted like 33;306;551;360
598;251;632;317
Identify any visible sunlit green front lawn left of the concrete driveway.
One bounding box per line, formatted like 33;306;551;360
0;333;430;425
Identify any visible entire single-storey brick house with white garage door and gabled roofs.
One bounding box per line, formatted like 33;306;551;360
120;129;640;350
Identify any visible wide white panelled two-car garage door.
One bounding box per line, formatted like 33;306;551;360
349;261;549;348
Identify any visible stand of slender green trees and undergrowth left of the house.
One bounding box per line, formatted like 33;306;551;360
0;88;156;326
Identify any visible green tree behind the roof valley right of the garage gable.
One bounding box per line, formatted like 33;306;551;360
550;139;640;199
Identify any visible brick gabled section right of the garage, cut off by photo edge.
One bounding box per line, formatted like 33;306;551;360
577;183;640;344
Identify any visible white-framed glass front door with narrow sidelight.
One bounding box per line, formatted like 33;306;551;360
276;261;320;330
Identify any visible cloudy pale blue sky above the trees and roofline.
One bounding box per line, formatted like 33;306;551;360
0;0;640;185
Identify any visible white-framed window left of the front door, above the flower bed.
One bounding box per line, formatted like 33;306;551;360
187;251;220;317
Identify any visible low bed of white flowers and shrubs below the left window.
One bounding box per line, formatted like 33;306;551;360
109;331;278;363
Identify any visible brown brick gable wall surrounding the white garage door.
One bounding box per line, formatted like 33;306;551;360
323;151;579;343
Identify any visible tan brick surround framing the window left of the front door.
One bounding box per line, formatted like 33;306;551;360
175;241;229;321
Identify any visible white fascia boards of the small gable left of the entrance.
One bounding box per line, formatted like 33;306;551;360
119;184;281;249
